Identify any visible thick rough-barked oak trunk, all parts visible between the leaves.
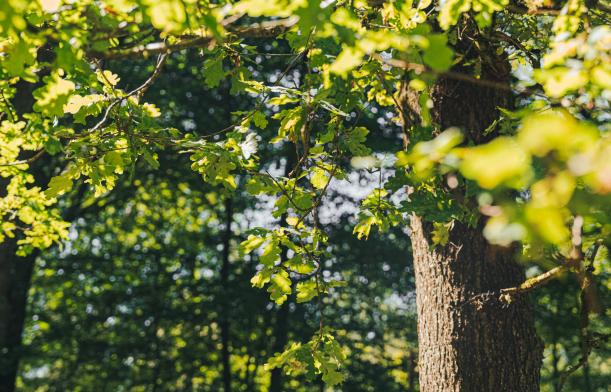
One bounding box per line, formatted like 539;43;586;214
402;47;542;392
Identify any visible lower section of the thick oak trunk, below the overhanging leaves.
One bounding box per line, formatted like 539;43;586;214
410;215;541;392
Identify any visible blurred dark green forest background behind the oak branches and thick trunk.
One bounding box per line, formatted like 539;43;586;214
18;47;611;392
